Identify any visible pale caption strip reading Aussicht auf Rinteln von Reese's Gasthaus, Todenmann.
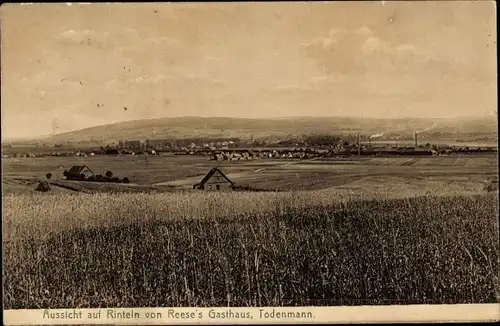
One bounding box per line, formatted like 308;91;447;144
4;304;500;325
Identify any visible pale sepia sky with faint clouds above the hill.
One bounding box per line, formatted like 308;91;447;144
0;1;497;138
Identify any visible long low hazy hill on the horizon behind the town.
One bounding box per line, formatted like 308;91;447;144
29;117;497;143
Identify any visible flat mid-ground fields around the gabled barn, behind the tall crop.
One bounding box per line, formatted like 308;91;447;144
2;155;497;194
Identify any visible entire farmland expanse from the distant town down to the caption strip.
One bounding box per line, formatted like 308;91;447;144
2;156;500;309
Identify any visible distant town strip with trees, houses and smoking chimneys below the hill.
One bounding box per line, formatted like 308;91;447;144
2;134;497;161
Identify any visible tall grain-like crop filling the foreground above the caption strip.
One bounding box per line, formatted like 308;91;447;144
3;192;499;309
